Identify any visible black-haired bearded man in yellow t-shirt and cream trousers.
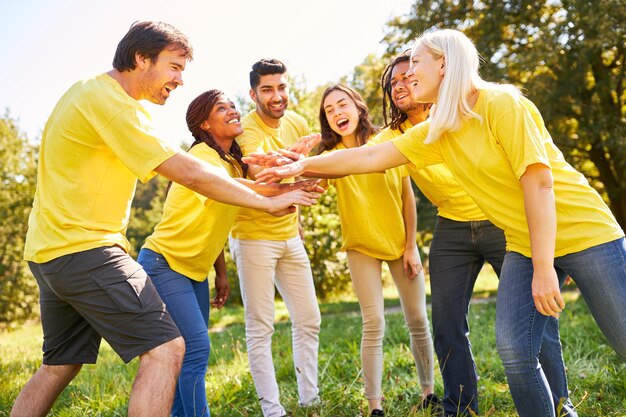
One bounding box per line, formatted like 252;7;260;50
230;59;321;417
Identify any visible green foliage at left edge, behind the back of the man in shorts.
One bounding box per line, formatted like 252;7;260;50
0;111;37;326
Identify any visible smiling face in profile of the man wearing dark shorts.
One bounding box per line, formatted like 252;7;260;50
138;49;187;104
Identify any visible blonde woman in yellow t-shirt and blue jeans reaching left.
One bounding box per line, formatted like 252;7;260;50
249;30;626;417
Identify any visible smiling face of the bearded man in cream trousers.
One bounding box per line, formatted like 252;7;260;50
250;74;289;127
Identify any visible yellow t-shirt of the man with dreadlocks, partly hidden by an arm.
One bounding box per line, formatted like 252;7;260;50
368;119;487;222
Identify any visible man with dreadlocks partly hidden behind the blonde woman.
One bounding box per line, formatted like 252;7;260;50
370;51;568;416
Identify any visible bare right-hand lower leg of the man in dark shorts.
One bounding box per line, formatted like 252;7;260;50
128;337;185;417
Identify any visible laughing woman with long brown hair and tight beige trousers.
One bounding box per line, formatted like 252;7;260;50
319;85;437;416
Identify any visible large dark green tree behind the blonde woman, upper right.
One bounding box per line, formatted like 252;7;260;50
385;0;626;228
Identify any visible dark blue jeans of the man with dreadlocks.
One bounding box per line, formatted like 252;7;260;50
429;217;574;416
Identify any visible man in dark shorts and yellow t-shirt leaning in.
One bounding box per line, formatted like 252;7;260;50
11;22;311;417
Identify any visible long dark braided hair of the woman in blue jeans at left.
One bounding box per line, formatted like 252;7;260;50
186;89;248;178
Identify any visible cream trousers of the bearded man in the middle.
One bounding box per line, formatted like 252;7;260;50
230;236;321;417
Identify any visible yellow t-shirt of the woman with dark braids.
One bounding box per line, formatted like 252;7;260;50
143;143;241;281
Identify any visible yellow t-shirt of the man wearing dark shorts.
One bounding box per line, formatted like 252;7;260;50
24;74;179;263
